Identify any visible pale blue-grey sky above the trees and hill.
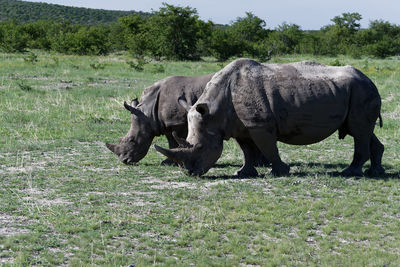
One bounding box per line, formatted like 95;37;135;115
29;0;400;30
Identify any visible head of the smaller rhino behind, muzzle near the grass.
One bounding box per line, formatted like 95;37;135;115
106;99;154;164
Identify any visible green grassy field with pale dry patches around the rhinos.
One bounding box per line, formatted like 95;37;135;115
0;52;400;266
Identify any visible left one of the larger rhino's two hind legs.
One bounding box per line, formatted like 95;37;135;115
342;134;371;176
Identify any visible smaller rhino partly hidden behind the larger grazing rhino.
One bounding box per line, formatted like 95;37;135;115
106;73;268;172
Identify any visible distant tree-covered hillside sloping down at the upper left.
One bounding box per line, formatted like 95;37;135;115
0;0;150;25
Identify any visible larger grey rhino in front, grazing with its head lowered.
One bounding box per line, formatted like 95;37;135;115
156;59;384;179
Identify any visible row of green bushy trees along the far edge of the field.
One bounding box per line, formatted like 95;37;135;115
0;3;400;61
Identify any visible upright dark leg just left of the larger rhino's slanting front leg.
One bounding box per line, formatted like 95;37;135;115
235;138;258;177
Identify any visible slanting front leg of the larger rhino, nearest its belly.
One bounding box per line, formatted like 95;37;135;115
249;129;290;176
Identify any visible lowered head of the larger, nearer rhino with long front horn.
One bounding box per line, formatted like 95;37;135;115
155;99;223;176
